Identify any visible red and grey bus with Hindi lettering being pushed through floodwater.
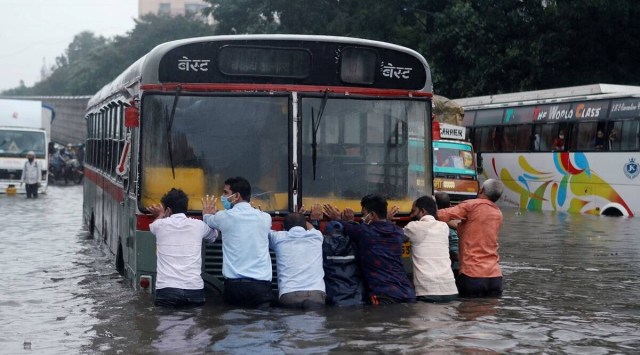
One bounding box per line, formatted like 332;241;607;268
83;35;432;292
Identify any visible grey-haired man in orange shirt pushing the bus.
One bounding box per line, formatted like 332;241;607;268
438;179;504;297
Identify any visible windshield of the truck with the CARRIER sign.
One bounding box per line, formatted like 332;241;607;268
433;141;476;175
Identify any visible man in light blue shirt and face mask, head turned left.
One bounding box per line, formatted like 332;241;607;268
202;177;274;308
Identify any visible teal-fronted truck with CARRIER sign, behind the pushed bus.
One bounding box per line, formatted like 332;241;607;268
431;121;478;204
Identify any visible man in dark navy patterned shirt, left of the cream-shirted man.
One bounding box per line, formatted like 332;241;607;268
324;194;416;305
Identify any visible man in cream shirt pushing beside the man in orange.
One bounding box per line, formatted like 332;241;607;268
404;196;458;302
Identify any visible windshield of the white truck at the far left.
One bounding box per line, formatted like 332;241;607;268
0;129;46;159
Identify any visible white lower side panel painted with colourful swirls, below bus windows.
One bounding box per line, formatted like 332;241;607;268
481;152;640;216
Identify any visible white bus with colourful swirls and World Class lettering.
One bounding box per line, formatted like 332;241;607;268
456;84;640;217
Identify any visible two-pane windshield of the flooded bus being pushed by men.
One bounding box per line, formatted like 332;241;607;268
140;94;429;213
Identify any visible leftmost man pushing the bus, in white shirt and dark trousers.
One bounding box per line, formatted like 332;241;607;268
147;188;218;308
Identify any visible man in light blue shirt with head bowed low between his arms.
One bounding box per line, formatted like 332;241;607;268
269;213;326;309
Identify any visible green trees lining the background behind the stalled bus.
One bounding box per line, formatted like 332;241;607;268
5;0;640;97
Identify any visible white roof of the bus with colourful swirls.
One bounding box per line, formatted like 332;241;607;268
454;84;640;109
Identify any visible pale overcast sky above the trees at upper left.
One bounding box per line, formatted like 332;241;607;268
0;0;138;91
